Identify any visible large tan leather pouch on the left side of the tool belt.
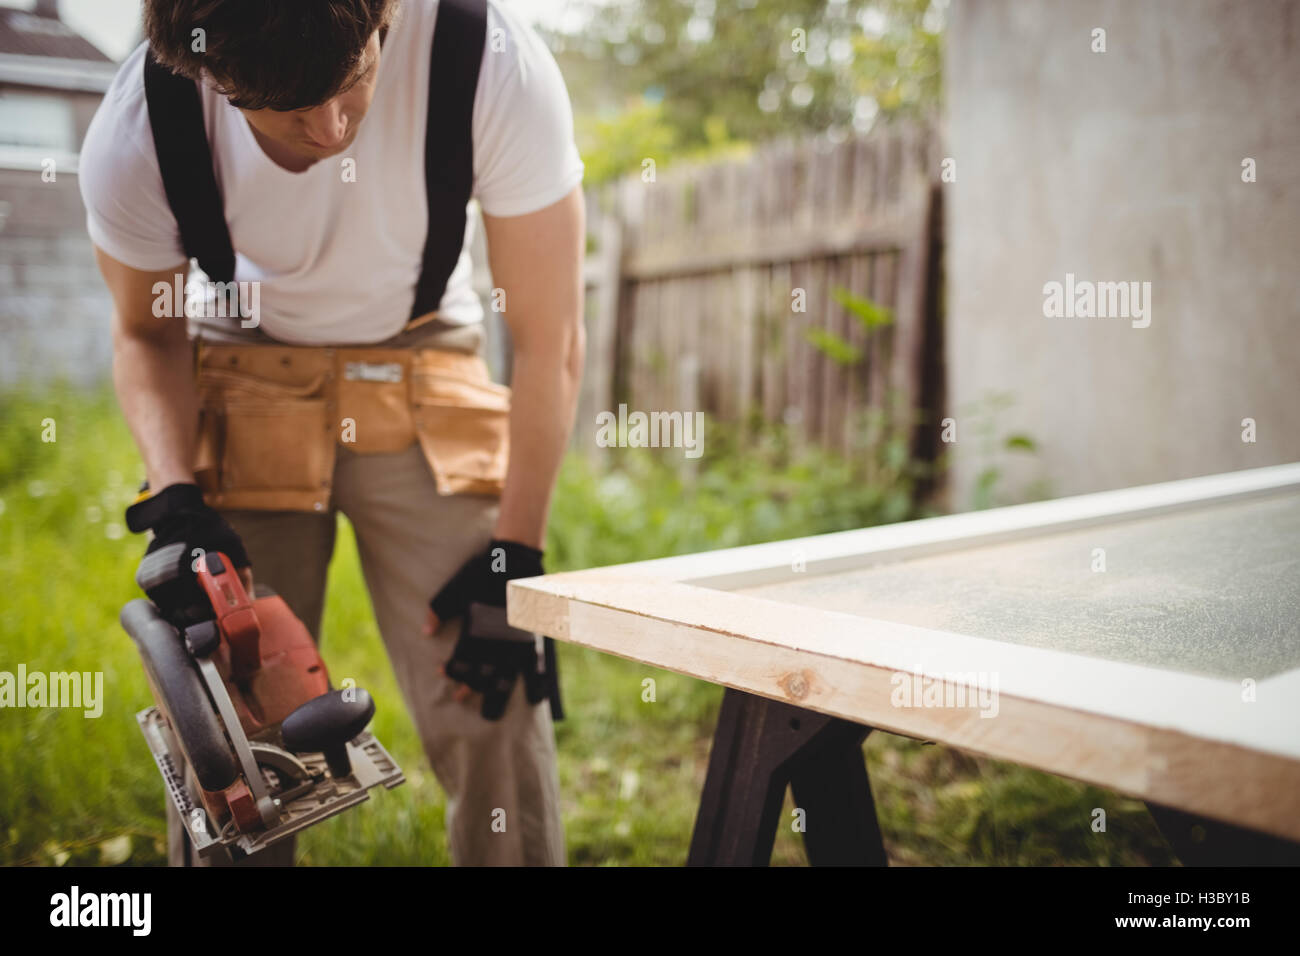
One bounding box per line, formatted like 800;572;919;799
195;347;337;511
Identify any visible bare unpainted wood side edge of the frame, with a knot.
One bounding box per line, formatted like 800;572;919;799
535;598;1300;840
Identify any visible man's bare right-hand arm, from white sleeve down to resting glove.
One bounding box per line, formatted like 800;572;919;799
484;187;586;549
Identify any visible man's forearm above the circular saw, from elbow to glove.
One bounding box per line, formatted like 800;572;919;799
113;323;199;489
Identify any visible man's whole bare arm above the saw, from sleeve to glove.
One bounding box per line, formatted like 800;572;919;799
95;247;199;490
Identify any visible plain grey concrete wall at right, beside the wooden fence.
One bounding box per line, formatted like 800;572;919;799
944;0;1300;509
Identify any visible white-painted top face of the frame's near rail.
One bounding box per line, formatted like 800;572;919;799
511;575;1300;760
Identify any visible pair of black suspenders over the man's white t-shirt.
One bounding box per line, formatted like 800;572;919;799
144;0;488;319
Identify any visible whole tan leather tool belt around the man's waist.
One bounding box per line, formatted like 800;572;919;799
195;342;510;511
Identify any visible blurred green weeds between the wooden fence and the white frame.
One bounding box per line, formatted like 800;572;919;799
547;414;926;570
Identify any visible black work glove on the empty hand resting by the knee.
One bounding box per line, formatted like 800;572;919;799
429;538;564;721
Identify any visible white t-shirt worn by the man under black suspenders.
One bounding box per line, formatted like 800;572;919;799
81;0;582;345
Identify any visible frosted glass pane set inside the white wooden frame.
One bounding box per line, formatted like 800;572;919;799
738;492;1300;680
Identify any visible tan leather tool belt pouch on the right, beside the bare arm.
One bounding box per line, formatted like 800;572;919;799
411;351;510;494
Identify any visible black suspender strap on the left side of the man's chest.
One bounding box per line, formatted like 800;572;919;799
144;49;235;282
